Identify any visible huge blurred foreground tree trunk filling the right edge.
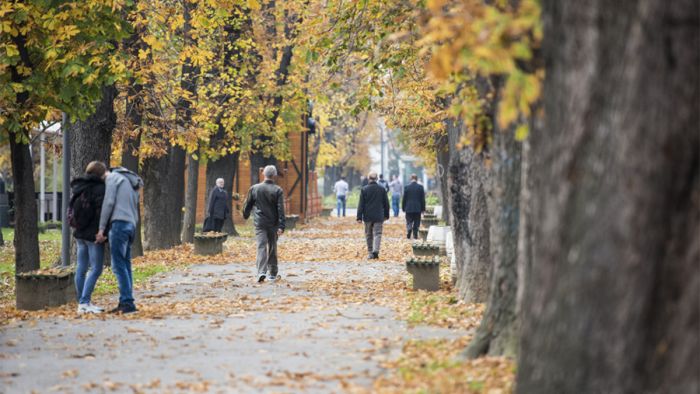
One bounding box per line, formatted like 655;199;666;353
517;0;700;393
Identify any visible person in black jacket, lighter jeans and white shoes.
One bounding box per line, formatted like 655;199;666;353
68;161;107;314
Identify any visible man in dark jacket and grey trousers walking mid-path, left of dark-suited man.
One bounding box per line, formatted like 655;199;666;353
357;172;389;260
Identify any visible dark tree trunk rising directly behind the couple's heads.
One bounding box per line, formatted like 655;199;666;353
69;85;117;178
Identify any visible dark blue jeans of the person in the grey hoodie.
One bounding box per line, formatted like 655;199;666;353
109;220;136;305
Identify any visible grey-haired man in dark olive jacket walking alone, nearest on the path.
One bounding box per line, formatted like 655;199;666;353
243;166;284;282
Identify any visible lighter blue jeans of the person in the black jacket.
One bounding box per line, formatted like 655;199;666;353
75;239;105;304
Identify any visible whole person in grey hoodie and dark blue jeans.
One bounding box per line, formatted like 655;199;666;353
96;167;143;313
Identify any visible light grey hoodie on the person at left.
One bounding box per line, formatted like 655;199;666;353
100;167;143;230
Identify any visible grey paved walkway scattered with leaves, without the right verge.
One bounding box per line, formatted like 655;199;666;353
0;218;463;393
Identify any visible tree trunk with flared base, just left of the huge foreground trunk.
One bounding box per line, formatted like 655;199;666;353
465;121;521;358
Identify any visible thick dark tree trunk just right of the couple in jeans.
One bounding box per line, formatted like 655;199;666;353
143;146;185;250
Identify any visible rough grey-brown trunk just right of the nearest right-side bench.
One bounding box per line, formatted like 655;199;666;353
448;147;491;302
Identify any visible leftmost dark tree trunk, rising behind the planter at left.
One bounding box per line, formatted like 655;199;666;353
9;134;40;273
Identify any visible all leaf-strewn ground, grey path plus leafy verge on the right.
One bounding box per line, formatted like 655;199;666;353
0;218;514;393
